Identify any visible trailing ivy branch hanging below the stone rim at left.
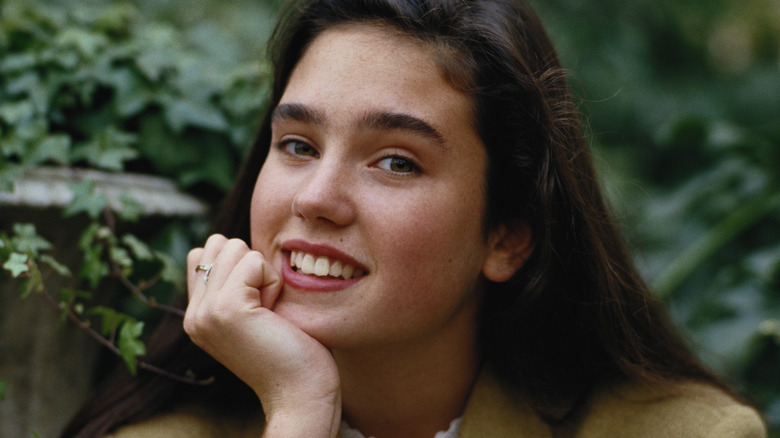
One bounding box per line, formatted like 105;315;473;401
0;194;211;385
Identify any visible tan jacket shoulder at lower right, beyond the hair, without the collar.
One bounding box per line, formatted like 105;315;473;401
572;382;766;438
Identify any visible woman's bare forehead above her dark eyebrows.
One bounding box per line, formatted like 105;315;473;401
280;24;474;139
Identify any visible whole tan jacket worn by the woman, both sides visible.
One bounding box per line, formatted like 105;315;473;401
106;375;766;438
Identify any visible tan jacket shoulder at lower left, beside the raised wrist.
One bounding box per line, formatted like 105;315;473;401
106;405;264;438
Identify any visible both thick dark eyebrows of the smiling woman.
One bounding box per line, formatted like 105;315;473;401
271;103;445;146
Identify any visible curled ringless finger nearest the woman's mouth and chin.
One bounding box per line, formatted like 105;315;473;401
223;251;282;310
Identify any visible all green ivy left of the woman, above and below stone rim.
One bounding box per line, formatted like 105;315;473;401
0;0;271;428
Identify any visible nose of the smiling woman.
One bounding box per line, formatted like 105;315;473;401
292;159;355;226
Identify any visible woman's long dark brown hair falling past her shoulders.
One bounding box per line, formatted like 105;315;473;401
63;0;720;436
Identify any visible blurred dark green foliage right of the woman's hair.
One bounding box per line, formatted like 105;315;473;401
531;0;780;435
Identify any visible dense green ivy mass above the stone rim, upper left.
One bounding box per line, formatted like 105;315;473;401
0;0;267;193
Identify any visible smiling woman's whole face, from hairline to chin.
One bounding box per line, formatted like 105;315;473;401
251;25;500;348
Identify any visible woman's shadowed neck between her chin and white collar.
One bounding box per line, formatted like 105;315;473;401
333;320;479;438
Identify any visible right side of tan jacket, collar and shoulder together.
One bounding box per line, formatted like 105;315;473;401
459;373;767;438
